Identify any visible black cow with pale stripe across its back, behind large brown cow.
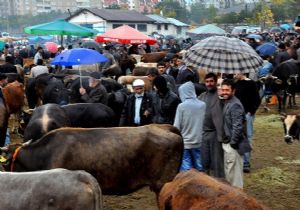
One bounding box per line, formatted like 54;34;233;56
24;103;119;141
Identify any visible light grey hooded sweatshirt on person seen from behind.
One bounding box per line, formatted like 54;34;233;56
174;82;206;149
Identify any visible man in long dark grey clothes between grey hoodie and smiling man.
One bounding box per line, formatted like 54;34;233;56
199;73;225;178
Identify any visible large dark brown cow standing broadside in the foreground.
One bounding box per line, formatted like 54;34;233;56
5;124;183;195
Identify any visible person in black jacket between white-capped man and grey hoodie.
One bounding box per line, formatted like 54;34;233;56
152;76;180;125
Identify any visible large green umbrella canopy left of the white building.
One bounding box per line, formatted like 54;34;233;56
24;19;96;44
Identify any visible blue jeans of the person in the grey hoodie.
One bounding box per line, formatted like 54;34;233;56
180;148;203;171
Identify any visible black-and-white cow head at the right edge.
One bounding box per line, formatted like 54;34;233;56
281;114;300;144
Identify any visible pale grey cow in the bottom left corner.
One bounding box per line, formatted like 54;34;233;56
0;169;102;210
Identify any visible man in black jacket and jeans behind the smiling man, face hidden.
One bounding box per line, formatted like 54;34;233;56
235;73;261;173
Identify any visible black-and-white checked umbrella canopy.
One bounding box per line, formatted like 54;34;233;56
185;36;263;74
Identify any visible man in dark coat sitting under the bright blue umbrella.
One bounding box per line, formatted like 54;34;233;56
79;72;108;105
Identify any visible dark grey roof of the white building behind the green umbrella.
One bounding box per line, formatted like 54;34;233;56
67;8;155;23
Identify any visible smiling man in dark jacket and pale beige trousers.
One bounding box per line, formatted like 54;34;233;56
221;80;251;188
